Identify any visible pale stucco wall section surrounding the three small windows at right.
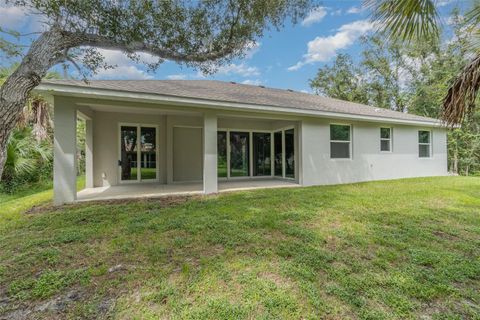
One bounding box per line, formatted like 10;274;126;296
299;118;447;186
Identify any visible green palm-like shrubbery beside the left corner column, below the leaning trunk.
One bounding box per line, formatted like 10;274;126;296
2;127;52;192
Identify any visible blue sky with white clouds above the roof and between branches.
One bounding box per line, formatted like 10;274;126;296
0;0;469;92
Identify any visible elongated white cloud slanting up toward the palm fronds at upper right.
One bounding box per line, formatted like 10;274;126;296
288;20;374;71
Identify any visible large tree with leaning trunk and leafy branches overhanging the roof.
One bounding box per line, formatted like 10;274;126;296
0;0;314;176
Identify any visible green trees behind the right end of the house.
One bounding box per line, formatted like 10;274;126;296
310;12;480;174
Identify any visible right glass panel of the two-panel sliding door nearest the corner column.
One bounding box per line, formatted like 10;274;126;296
140;127;157;180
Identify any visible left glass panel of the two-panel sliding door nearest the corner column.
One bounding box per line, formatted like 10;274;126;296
120;126;138;181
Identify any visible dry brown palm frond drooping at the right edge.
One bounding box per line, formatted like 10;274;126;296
442;55;480;126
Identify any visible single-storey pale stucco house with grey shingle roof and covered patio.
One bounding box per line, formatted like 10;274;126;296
37;80;447;204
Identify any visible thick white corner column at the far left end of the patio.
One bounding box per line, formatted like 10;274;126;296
53;98;77;205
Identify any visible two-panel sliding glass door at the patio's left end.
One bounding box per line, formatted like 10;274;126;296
118;125;157;182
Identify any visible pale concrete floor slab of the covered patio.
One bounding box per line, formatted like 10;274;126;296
77;179;299;202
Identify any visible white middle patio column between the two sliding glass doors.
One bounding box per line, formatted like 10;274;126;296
203;113;218;194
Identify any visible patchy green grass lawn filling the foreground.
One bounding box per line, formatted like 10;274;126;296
0;177;480;319
